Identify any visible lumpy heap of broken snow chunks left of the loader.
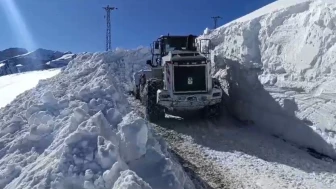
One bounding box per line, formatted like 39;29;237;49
0;49;194;189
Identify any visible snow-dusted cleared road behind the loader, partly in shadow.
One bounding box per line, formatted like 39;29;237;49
128;96;336;189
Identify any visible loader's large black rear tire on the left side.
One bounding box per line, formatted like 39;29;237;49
146;80;165;121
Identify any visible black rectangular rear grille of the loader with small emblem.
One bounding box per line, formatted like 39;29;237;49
174;65;206;93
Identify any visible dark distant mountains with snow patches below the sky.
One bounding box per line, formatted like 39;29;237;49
0;49;71;76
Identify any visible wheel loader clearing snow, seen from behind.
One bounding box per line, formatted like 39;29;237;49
133;35;223;121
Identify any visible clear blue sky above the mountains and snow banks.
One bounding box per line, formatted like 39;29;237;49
0;0;274;53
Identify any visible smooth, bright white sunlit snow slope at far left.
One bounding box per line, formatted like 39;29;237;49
0;69;60;108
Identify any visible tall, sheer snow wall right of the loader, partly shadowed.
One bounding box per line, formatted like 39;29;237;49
200;0;336;158
